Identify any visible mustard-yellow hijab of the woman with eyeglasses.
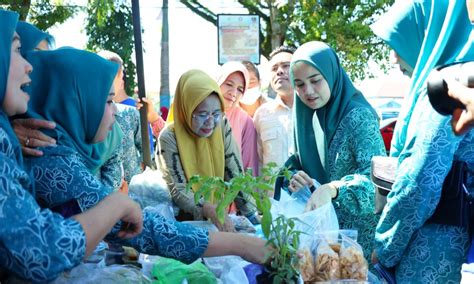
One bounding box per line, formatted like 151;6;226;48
167;70;225;181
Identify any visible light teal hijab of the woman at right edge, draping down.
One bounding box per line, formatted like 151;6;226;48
372;0;474;157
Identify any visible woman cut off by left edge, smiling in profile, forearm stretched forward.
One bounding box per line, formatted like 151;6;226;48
0;9;142;283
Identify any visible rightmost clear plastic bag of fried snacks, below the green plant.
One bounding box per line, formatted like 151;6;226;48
340;247;368;281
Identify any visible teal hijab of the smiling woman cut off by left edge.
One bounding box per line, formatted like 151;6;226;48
0;10;23;166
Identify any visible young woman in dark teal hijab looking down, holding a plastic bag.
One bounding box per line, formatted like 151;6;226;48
280;41;385;264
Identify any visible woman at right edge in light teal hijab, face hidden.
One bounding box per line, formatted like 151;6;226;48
372;0;474;283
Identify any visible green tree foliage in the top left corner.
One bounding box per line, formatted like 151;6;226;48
0;0;80;31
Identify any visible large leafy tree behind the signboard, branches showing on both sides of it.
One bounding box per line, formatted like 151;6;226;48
180;0;394;80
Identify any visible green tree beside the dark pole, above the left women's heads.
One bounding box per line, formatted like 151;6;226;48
85;0;136;95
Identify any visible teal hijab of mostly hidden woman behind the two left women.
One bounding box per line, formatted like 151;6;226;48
16;21;54;56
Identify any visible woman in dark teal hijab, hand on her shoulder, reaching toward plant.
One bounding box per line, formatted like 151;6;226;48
19;45;265;270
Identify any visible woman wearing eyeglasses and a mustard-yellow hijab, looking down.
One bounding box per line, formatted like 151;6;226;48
157;70;255;231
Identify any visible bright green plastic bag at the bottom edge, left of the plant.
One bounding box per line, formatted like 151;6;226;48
151;257;217;284
